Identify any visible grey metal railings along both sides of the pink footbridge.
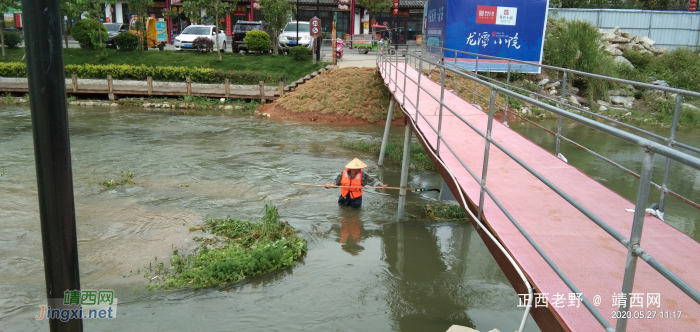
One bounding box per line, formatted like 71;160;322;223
377;48;700;332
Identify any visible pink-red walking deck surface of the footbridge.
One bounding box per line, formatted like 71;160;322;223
382;60;700;331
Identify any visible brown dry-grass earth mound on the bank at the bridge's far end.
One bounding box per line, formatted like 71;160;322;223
275;68;403;123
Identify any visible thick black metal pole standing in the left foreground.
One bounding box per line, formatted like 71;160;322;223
22;0;83;332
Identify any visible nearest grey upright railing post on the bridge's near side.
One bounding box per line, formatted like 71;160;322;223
613;149;654;332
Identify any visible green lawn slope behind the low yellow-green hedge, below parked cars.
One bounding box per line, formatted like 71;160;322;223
0;48;325;84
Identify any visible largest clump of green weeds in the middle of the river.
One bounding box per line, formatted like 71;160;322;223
144;204;307;289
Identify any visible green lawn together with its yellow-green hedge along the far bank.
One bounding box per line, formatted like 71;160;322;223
0;48;325;84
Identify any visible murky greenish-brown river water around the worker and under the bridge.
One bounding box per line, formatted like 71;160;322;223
0;107;700;331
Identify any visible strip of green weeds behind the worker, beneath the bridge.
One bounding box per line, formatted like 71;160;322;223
340;140;435;171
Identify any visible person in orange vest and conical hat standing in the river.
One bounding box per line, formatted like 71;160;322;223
324;158;387;209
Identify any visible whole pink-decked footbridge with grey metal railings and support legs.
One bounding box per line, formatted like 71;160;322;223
377;49;700;332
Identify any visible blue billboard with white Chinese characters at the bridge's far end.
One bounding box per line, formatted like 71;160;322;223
426;0;549;73
